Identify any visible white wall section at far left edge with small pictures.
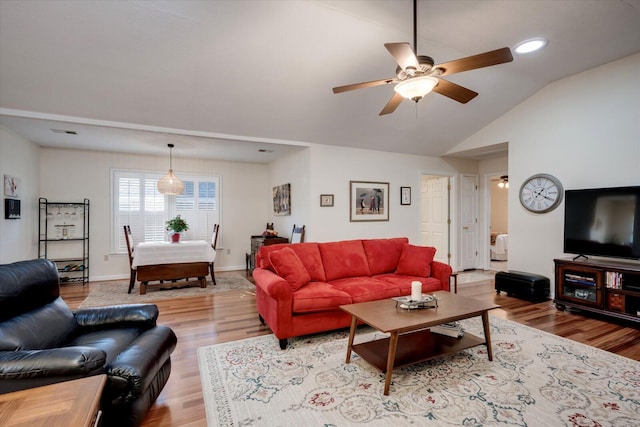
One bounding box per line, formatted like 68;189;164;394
0;126;39;264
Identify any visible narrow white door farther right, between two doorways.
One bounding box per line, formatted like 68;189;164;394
460;175;478;270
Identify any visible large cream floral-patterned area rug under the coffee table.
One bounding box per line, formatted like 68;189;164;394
198;316;640;427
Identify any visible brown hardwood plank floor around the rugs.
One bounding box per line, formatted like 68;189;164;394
61;272;640;427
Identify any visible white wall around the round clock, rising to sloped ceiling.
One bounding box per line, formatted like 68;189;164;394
456;54;640;281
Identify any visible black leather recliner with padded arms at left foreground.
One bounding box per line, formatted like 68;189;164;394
0;259;177;426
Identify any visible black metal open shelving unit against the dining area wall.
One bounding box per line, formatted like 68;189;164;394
38;197;89;286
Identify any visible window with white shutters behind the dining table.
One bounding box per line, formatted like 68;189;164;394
111;170;220;253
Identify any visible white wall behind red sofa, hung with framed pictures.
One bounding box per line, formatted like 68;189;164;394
298;145;477;270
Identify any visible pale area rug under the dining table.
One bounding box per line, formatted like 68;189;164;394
79;273;256;308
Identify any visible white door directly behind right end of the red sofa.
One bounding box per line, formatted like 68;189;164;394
420;175;451;264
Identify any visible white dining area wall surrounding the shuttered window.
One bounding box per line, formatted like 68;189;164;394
38;148;271;281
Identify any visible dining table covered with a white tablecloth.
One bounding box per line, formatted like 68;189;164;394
131;240;216;294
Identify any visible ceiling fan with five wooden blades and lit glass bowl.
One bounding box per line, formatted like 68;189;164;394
333;0;513;116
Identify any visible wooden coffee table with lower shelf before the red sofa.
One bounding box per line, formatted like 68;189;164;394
340;291;500;395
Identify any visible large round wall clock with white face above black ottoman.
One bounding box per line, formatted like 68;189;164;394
520;173;564;213
